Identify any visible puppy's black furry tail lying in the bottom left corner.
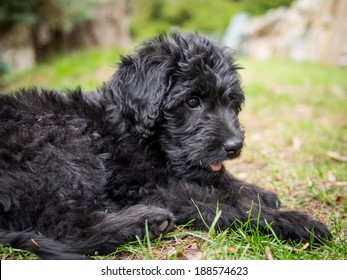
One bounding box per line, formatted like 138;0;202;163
0;229;86;260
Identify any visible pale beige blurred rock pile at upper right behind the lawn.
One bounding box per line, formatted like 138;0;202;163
229;0;347;66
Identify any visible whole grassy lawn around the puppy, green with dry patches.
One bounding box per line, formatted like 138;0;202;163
0;46;347;260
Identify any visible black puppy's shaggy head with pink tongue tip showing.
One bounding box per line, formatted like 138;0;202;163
106;32;244;178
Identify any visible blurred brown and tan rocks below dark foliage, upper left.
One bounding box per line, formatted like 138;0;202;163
0;0;130;72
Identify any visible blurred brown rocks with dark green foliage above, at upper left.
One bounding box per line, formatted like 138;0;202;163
0;0;130;72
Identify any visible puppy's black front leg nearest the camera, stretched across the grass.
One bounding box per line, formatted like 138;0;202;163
165;184;331;242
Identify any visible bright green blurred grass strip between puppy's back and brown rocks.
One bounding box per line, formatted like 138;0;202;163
0;49;122;92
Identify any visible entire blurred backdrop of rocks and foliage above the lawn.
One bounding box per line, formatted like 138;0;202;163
0;0;347;76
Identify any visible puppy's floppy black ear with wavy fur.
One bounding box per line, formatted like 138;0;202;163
106;39;177;138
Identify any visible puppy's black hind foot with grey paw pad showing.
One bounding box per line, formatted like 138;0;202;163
63;205;174;255
